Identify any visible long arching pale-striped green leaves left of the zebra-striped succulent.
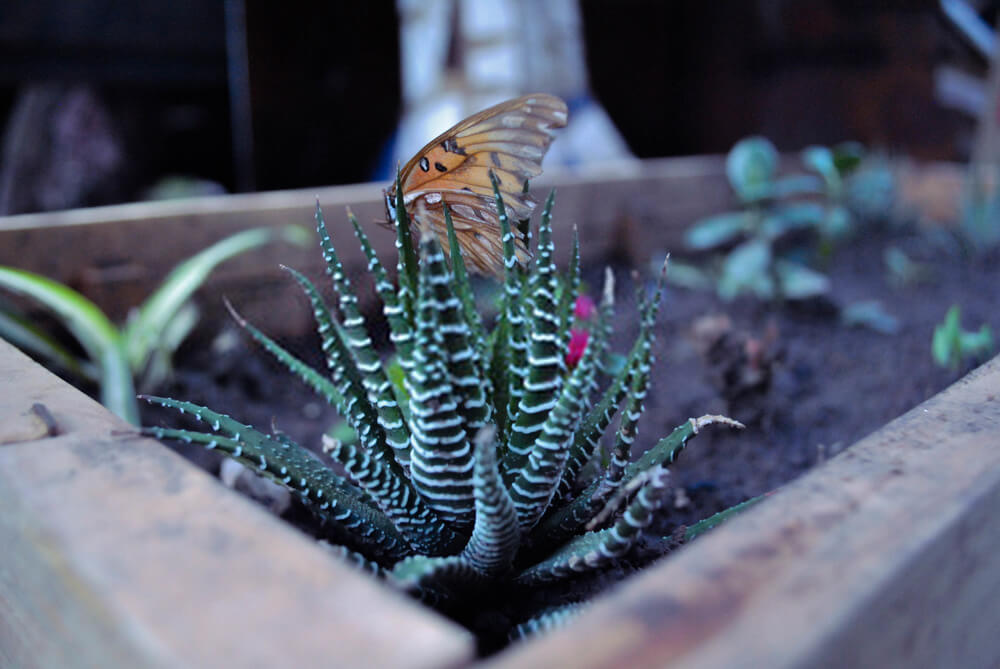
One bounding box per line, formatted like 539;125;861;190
0;226;305;424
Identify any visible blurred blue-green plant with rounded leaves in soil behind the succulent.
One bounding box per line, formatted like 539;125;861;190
679;137;895;299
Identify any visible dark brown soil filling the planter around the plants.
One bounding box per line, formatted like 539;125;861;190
143;222;1000;650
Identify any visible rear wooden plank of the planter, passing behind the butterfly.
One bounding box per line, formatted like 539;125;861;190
0;157;729;336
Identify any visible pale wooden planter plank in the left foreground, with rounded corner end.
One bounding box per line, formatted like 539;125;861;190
0;341;474;667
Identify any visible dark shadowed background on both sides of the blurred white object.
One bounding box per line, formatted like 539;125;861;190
0;0;994;213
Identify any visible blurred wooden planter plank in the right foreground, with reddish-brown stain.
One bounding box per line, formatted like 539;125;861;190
487;357;1000;669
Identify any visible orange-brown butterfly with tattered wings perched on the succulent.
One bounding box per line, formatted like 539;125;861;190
385;93;567;276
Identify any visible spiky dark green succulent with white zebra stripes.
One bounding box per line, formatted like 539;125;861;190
145;175;742;632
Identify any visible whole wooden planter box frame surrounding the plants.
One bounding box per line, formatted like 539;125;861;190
0;158;1000;668
